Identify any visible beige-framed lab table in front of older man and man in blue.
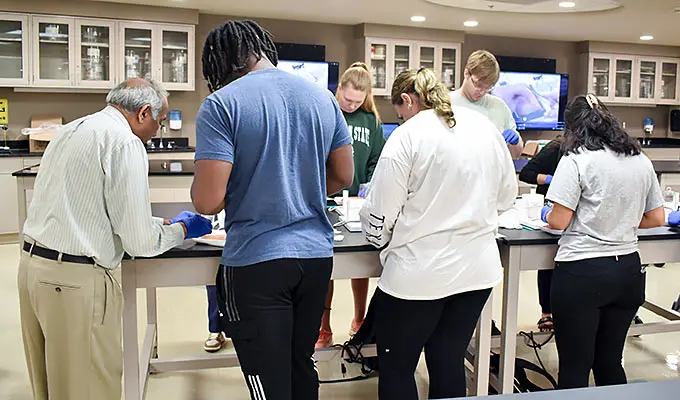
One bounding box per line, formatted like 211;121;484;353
121;204;491;400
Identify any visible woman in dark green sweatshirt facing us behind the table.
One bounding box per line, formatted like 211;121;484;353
316;62;385;349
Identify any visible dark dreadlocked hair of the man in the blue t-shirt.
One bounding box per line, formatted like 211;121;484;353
201;20;279;92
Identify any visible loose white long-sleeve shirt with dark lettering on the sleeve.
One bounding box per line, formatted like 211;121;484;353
360;107;517;300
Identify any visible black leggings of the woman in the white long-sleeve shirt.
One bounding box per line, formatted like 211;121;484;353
376;289;491;400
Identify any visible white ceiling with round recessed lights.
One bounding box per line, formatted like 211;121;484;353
96;0;680;46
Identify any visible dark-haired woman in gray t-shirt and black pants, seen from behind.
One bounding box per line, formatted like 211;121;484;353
542;95;664;389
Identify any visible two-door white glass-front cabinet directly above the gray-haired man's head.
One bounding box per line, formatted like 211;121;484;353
118;22;196;91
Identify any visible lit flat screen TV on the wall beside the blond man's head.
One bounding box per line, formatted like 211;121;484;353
491;71;569;131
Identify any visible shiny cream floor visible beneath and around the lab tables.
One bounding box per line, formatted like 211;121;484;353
0;245;680;400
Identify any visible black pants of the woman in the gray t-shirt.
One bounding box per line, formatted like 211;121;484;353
552;253;645;389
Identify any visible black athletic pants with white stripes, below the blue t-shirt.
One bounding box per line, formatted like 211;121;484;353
216;258;333;400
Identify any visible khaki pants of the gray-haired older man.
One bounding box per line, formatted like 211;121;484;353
18;251;123;400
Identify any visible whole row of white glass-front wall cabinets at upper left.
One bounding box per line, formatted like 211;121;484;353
0;13;196;91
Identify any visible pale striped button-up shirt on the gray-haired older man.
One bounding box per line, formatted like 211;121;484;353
24;106;184;269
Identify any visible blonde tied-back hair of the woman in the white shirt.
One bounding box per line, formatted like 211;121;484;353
392;68;456;128
